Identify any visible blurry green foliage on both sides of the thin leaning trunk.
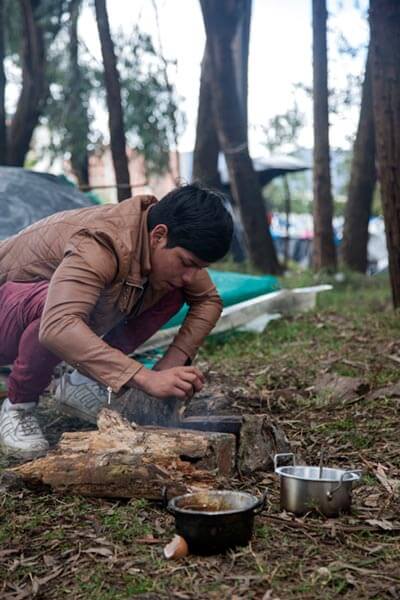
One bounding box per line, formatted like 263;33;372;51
43;17;184;174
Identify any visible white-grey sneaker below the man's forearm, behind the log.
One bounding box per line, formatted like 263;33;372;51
55;374;111;425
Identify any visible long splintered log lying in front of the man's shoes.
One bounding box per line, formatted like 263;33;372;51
11;409;236;500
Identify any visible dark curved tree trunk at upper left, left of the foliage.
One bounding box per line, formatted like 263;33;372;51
7;0;46;167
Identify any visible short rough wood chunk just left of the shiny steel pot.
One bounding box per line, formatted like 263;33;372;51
237;415;290;475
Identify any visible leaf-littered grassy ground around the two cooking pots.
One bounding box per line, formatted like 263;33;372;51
0;276;400;600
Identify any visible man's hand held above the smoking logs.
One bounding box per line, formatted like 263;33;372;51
128;367;204;400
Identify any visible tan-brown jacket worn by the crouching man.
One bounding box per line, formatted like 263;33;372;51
0;196;222;392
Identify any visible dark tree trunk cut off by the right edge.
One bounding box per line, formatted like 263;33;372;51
369;0;400;307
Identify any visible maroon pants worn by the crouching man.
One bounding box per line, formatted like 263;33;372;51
0;281;183;403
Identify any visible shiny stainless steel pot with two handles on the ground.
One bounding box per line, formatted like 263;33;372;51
275;454;362;517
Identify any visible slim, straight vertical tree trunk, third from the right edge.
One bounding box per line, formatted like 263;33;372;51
312;0;336;271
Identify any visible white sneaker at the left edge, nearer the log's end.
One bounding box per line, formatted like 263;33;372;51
0;398;49;460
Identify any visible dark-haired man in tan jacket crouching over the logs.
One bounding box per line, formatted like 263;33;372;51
0;185;232;458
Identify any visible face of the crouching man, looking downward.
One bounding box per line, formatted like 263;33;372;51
149;225;209;290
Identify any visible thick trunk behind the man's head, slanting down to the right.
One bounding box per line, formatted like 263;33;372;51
200;0;280;274
